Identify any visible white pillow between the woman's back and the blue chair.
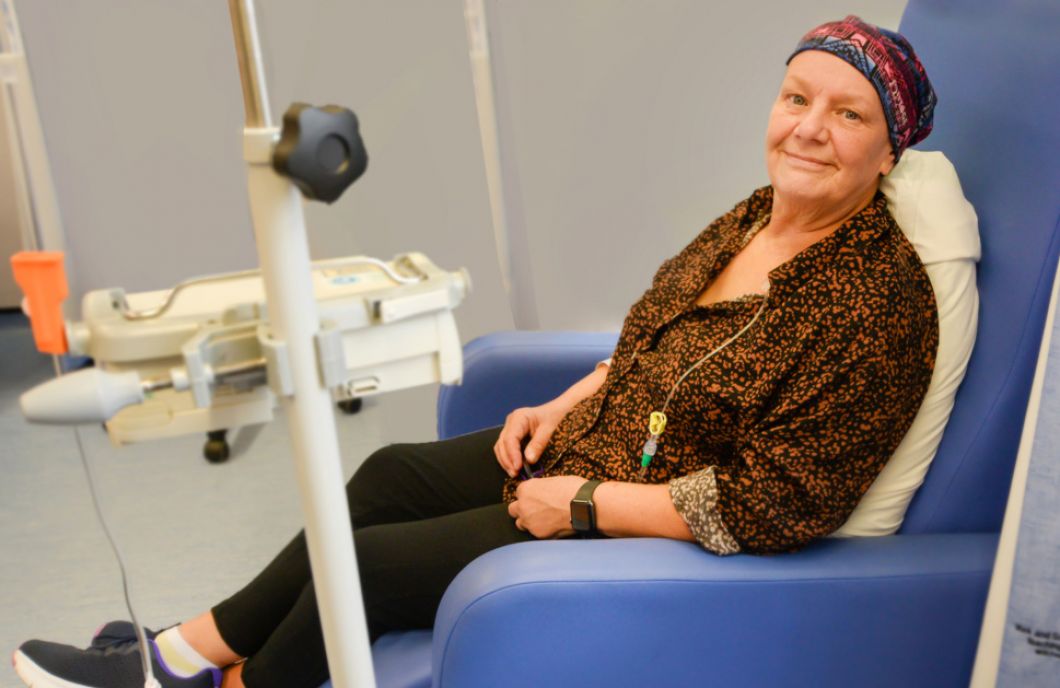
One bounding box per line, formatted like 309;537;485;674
833;151;979;537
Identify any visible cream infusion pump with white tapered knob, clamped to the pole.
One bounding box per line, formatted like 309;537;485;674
22;253;471;444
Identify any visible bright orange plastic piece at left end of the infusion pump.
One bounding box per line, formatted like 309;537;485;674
11;251;69;354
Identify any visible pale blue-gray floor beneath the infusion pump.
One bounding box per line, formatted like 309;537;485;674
0;313;437;687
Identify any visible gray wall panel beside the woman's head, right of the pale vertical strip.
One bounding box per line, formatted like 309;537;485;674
491;0;905;330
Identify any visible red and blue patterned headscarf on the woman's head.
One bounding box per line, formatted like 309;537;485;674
788;15;938;162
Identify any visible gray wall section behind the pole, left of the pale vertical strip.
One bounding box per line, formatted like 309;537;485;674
18;0;511;338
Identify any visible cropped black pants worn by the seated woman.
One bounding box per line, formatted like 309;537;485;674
213;428;533;688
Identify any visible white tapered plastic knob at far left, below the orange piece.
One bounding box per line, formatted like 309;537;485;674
19;368;143;425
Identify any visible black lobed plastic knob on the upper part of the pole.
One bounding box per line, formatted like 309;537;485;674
272;103;368;204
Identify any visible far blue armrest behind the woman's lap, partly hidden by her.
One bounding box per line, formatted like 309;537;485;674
438;331;618;440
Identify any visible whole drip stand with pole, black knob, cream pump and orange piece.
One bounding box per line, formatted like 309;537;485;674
13;0;471;688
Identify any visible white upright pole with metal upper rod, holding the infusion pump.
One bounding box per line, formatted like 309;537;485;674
228;0;375;688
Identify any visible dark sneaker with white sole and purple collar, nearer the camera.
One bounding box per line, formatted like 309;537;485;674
14;640;222;688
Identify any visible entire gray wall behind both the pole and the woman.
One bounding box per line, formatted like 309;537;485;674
10;0;904;340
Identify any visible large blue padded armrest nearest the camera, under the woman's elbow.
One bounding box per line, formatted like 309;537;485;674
432;533;997;688
